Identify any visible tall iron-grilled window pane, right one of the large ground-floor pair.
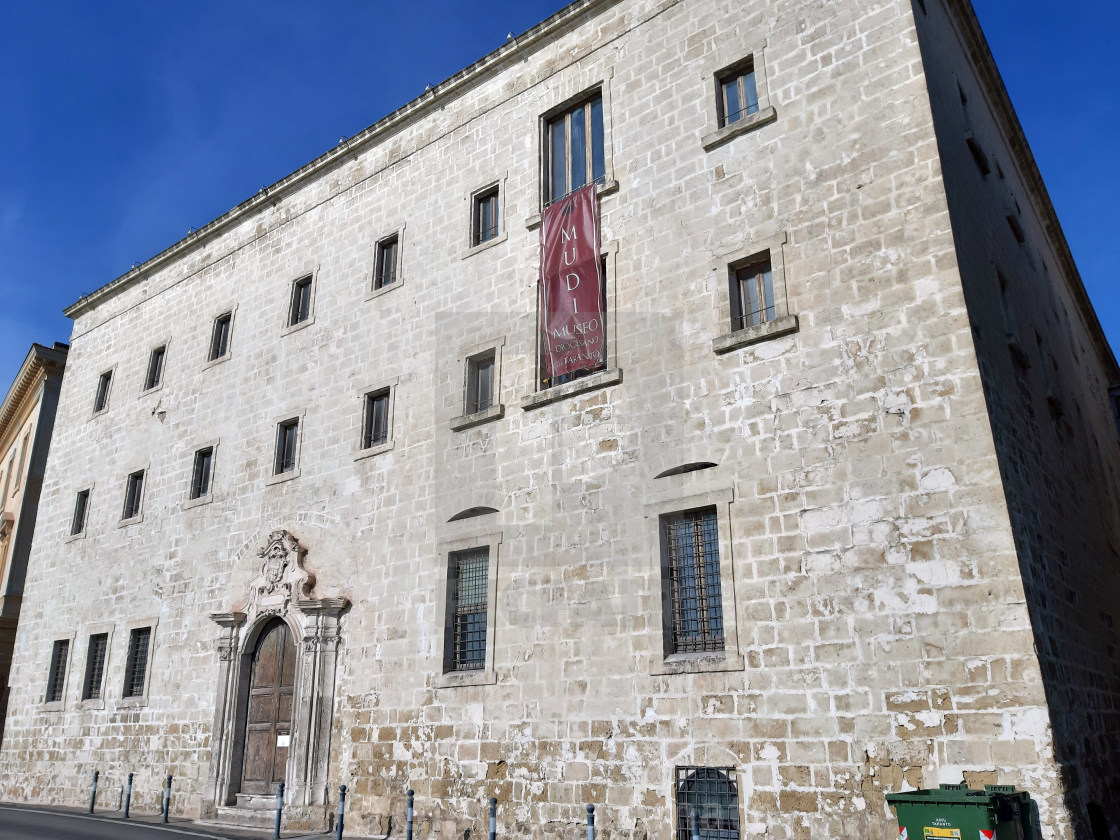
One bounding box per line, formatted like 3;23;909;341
661;507;724;653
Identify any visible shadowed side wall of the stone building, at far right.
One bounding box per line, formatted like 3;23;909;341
916;2;1120;838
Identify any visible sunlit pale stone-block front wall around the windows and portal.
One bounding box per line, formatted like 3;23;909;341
0;0;1088;840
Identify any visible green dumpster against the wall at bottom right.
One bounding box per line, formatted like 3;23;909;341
887;784;1042;840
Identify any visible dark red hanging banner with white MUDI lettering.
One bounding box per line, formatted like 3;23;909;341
540;184;606;379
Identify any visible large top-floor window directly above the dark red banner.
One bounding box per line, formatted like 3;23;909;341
548;92;606;202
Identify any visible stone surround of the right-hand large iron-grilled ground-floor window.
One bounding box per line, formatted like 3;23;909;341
643;486;746;676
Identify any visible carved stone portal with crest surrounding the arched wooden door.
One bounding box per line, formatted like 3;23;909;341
206;530;349;815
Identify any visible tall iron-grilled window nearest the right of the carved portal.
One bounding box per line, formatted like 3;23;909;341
444;548;489;671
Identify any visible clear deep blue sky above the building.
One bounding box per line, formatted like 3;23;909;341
0;0;1120;394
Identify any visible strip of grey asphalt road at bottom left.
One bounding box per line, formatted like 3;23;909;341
0;805;333;840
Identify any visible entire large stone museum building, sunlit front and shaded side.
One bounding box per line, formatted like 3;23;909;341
0;0;1120;840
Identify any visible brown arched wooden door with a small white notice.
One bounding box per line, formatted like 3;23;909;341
241;618;296;794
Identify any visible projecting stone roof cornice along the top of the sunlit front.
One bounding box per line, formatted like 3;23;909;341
63;0;619;318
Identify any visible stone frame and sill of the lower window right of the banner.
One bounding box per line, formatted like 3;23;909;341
708;231;799;355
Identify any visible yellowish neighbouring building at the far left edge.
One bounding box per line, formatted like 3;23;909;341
0;344;67;743
